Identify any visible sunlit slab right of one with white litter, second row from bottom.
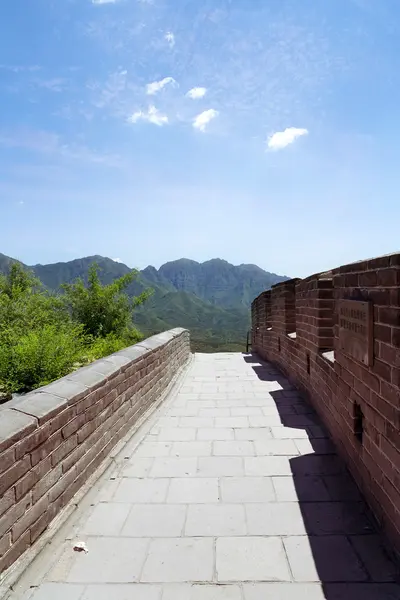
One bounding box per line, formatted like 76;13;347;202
141;538;214;583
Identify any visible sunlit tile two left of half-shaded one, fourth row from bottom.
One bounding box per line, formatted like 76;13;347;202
167;477;219;504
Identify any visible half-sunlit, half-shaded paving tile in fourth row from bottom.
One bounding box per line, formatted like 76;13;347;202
272;475;330;502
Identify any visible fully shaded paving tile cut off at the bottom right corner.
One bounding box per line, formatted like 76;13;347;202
324;583;400;600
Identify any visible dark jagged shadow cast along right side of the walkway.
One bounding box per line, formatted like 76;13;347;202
244;355;400;600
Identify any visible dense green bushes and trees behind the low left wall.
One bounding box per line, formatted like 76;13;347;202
0;263;149;395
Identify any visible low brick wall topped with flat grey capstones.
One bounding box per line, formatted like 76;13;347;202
0;329;190;572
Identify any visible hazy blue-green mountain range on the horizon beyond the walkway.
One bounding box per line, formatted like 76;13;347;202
0;254;287;351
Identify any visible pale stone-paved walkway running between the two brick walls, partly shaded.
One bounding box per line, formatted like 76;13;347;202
14;354;400;600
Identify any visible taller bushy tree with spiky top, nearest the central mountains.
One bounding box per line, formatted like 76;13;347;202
61;263;152;339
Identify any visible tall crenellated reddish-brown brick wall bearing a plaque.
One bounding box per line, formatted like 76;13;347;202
252;254;400;552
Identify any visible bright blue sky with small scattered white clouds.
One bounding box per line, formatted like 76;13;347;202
0;0;400;277
